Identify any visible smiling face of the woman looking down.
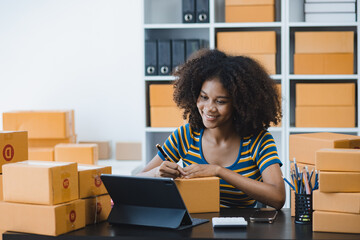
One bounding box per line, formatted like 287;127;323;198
196;77;233;128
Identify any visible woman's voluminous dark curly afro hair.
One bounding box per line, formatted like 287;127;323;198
173;49;281;137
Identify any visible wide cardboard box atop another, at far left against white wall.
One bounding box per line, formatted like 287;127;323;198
3;110;76;161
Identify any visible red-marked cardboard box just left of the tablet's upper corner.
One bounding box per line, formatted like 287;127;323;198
78;164;111;198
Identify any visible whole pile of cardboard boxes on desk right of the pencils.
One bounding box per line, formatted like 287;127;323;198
289;132;360;232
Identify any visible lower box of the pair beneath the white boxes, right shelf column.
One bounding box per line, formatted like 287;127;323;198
294;53;354;74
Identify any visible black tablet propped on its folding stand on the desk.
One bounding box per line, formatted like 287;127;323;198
101;174;209;230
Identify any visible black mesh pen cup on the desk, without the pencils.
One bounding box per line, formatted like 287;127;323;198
295;193;313;224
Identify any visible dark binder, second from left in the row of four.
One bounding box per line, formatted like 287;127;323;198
158;40;171;75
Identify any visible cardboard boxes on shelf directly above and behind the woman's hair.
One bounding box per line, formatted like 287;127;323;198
217;31;276;74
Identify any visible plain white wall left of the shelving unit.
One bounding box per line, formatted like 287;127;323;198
0;0;145;158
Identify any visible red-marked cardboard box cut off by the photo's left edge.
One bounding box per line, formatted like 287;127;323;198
0;131;28;173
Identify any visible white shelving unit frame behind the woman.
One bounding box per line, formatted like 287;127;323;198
143;0;360;206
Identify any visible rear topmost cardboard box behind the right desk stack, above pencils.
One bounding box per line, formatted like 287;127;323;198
289;132;360;165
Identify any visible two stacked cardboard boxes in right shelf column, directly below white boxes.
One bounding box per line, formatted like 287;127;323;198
294;31;354;74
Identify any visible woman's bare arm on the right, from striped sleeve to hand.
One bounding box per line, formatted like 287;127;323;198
184;164;285;209
